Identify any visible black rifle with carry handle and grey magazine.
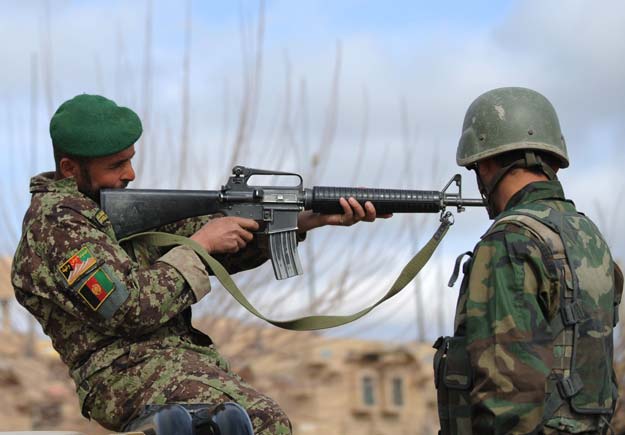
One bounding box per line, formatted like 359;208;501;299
100;166;484;279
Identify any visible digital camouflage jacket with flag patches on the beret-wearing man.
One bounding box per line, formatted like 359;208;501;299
12;173;267;408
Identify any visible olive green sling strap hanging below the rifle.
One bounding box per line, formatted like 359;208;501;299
119;216;453;331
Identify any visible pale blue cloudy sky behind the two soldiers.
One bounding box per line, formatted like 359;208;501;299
0;0;625;340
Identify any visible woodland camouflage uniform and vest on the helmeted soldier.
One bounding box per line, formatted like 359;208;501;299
435;181;620;434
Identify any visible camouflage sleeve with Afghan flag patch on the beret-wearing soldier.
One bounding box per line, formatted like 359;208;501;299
21;206;202;336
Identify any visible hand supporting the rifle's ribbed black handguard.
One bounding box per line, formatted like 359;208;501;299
297;198;392;232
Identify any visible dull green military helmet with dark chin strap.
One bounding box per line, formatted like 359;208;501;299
456;88;569;168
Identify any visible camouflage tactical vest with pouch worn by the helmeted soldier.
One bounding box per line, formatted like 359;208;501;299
434;202;623;435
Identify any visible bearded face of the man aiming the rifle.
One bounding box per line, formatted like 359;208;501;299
74;145;135;203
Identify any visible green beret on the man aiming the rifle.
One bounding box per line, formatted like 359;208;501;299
50;94;143;157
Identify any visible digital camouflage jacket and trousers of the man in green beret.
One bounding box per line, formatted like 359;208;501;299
12;173;290;434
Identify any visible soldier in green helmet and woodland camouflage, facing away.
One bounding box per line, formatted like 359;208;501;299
434;88;623;435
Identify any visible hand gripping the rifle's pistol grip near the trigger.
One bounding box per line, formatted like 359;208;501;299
191;216;258;254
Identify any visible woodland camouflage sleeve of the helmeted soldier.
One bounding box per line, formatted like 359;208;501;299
466;225;553;434
